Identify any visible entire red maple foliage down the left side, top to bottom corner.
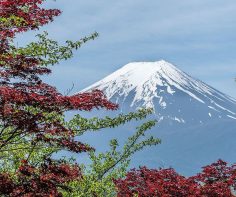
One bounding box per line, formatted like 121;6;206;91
0;0;117;196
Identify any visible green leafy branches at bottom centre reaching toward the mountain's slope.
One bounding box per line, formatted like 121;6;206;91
64;109;161;197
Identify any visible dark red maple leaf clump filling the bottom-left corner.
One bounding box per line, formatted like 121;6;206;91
0;160;82;197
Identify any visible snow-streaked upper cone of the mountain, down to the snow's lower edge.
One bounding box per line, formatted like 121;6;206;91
83;60;236;123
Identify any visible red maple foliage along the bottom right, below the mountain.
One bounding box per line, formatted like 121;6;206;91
114;160;236;197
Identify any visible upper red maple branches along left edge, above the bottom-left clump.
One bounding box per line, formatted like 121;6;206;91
0;0;117;153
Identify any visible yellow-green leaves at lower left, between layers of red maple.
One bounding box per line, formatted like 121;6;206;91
0;106;64;174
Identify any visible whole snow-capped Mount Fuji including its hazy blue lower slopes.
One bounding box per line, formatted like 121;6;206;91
81;60;236;175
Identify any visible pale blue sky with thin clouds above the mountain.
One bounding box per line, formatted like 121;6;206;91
18;0;236;97
